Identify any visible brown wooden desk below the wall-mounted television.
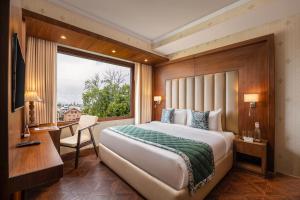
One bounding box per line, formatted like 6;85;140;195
9;128;63;191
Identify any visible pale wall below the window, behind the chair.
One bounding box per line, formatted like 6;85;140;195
60;118;134;155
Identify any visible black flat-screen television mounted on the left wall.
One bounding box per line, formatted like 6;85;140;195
12;33;25;112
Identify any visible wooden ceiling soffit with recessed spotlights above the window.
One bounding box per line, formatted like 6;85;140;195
22;9;169;65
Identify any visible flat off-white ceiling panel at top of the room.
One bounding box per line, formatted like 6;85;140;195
50;0;238;41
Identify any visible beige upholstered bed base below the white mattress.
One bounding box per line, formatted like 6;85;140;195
99;143;233;200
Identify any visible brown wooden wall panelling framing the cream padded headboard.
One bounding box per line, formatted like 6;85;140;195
153;34;275;171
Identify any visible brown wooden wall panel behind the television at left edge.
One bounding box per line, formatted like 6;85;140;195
0;0;25;199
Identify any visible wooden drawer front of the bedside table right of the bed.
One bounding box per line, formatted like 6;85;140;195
234;142;266;157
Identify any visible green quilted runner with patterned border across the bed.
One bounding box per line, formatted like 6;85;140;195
110;125;215;192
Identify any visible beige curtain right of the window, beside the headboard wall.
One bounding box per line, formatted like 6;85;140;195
135;63;152;124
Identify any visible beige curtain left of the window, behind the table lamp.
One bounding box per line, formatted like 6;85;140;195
26;37;57;124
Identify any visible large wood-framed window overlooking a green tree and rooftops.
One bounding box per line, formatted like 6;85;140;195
57;47;134;121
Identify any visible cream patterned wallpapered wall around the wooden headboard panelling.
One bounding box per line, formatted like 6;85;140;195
169;14;300;176
